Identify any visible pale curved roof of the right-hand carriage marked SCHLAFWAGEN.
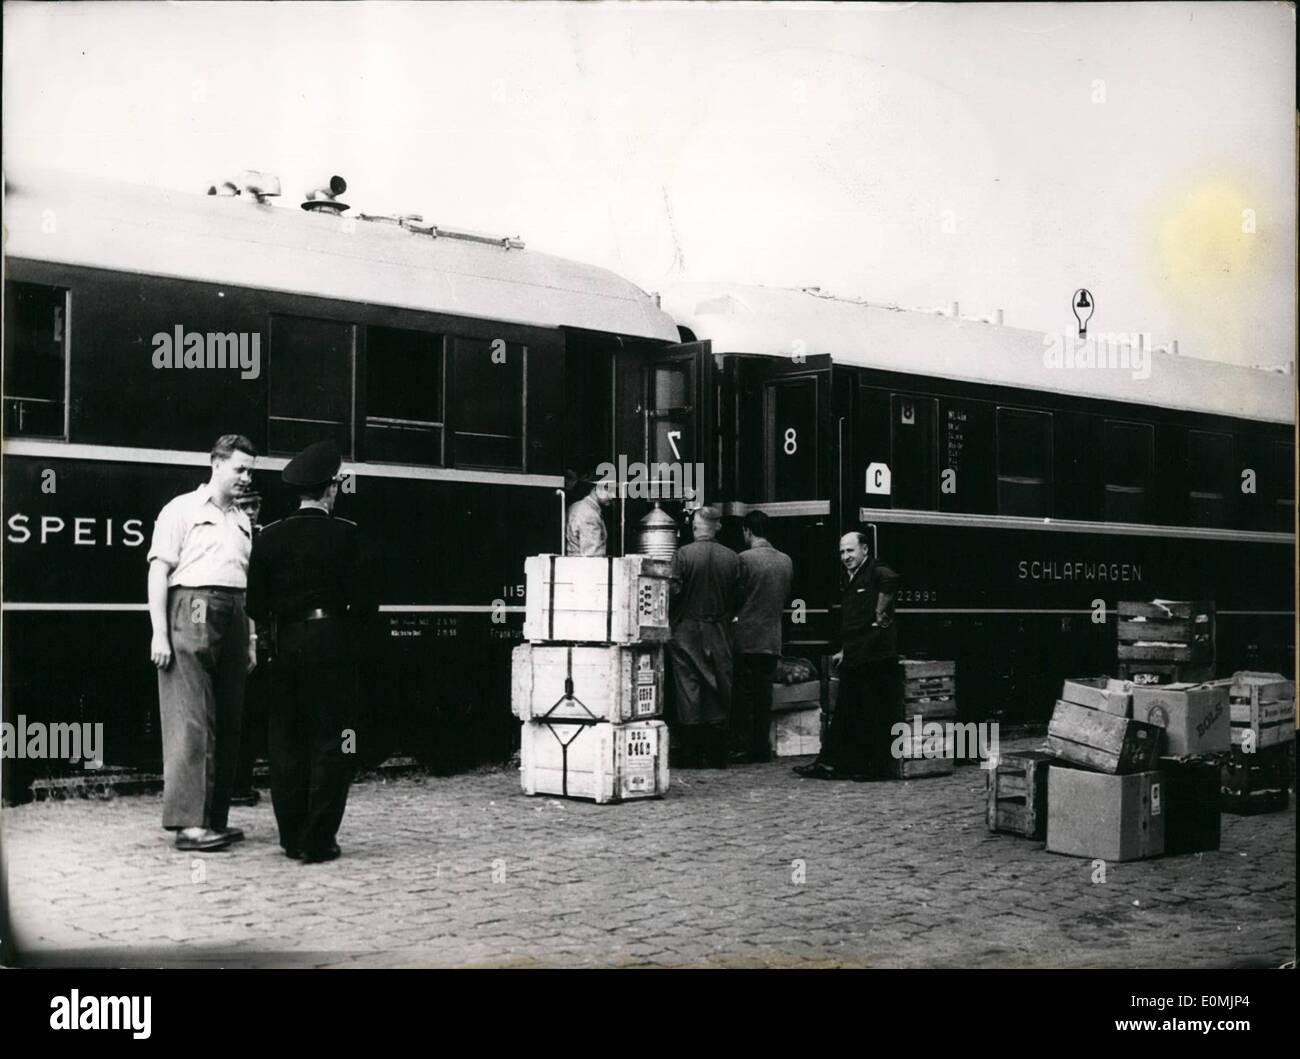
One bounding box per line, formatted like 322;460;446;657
663;283;1296;422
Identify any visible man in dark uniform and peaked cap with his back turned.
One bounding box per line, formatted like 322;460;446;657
248;442;369;863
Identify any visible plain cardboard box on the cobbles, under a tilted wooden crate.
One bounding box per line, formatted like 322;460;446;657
1048;764;1165;860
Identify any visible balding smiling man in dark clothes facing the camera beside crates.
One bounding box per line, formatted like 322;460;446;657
794;531;902;780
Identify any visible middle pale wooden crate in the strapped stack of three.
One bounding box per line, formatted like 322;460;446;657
510;643;663;722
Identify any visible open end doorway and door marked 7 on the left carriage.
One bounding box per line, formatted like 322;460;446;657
618;342;719;554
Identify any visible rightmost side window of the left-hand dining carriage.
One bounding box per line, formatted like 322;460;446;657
450;338;528;470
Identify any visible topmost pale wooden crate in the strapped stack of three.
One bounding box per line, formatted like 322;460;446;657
524;555;672;643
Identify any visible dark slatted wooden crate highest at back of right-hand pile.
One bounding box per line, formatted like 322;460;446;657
1117;599;1214;683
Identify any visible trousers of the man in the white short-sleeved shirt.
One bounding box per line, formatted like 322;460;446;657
159;587;248;830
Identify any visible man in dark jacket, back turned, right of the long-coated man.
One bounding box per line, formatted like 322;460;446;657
732;511;794;761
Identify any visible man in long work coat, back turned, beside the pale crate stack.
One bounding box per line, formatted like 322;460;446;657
668;508;741;768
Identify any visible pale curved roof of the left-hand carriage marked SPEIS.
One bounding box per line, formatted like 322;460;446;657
5;172;677;340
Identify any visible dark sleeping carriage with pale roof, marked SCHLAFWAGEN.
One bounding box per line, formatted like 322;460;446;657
659;283;1296;721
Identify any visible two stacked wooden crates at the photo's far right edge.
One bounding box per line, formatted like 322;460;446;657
1221;672;1296;813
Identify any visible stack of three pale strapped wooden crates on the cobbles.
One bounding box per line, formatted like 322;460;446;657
511;555;671;803
